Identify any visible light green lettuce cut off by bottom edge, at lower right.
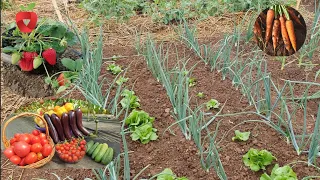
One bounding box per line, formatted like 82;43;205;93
260;164;298;180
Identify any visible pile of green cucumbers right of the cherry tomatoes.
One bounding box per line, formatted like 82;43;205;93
86;140;114;165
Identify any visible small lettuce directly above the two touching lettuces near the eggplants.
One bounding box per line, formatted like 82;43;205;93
120;89;140;109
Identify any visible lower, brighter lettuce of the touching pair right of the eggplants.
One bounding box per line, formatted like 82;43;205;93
130;122;158;144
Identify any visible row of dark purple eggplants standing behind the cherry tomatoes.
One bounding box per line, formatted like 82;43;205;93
44;107;91;144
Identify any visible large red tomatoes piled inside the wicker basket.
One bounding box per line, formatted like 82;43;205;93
3;130;53;166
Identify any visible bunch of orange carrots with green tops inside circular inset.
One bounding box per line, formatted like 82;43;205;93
254;5;305;55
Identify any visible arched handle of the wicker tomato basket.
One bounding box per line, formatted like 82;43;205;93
2;112;49;148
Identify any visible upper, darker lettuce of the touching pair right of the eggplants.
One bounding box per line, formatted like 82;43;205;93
125;109;155;131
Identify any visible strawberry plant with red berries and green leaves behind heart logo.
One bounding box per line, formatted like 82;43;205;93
1;2;77;71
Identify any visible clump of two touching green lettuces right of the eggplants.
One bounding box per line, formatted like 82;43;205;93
125;109;158;144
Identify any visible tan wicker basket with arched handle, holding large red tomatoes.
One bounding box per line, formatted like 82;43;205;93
2;113;56;168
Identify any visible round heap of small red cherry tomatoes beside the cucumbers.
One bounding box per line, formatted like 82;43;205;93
56;138;86;163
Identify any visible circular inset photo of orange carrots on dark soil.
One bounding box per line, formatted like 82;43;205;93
253;5;307;56
